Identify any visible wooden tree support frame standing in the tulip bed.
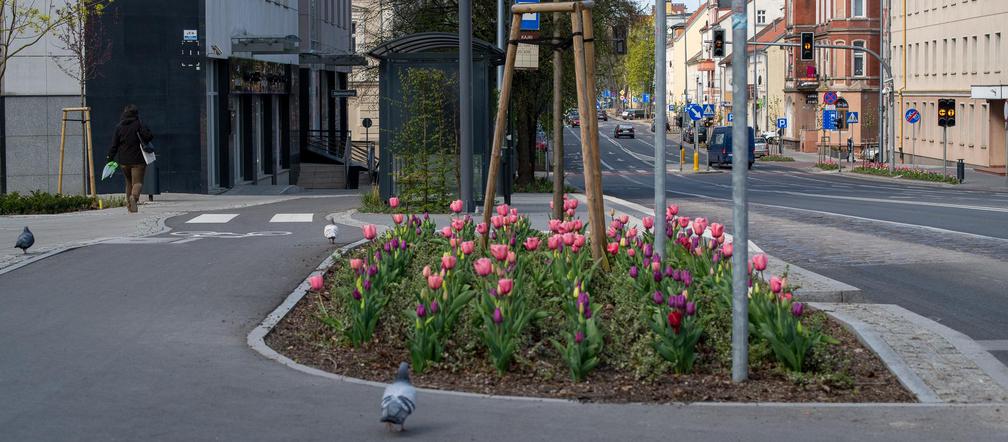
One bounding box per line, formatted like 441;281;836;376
483;1;609;271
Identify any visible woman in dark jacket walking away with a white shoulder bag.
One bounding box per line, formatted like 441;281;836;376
107;104;154;213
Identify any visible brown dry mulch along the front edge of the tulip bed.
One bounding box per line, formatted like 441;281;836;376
266;293;915;403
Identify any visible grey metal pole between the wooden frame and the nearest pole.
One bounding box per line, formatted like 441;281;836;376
654;2;668;256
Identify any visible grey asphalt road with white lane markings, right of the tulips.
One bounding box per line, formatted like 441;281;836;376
564;119;1008;363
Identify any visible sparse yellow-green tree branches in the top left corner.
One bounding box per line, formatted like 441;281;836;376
0;0;59;87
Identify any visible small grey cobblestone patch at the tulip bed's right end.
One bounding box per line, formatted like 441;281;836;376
816;304;1008;403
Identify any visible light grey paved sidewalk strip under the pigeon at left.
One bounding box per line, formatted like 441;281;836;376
0;192;354;269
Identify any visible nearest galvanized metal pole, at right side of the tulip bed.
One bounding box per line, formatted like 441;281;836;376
732;0;749;382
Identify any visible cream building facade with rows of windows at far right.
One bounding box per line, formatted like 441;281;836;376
891;0;1008;167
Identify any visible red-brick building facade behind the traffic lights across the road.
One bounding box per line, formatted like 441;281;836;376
784;0;881;151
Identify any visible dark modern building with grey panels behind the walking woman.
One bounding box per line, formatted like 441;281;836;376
3;0;351;193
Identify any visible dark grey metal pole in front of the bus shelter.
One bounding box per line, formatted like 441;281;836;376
459;0;471;212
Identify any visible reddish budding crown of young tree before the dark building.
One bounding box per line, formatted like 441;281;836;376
52;0;114;107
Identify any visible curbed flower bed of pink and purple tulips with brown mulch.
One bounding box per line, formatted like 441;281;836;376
266;194;912;402
